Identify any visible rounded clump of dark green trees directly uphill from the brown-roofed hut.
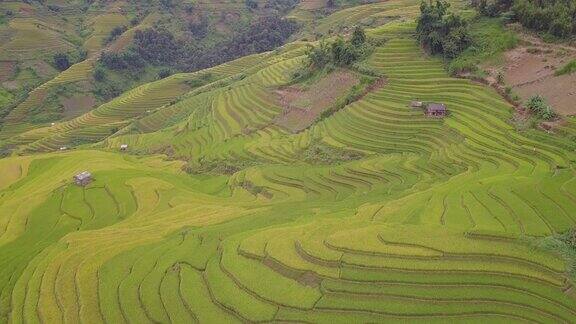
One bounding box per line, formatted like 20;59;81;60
416;0;470;58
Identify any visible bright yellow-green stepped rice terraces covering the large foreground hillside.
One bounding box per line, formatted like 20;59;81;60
0;0;576;323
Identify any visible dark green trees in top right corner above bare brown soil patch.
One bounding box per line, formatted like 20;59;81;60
512;0;576;38
